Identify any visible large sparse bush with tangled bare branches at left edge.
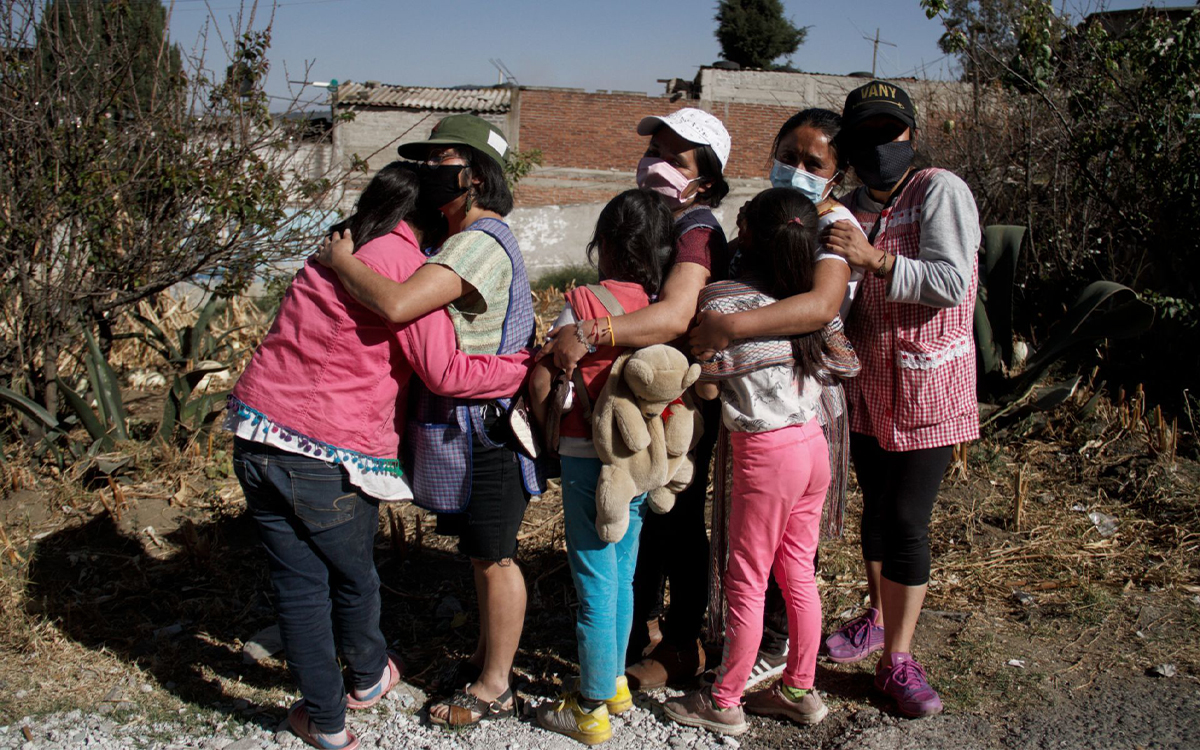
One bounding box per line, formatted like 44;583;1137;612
0;0;343;430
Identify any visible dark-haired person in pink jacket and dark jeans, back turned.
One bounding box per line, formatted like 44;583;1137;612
226;162;529;750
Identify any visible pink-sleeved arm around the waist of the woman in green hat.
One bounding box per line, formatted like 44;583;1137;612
396;306;533;398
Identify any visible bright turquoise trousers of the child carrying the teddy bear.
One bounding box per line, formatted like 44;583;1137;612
562;456;647;701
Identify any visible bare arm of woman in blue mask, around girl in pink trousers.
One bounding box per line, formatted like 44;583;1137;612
688;258;850;359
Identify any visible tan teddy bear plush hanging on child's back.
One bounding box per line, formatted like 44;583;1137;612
592;344;703;542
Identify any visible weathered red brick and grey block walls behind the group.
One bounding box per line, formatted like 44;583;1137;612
321;68;970;278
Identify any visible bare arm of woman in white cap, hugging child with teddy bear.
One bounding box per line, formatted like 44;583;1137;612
538;263;709;377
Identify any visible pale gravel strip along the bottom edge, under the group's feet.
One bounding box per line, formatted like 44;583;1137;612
0;677;1200;750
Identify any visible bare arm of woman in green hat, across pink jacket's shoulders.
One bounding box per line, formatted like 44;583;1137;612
317;229;474;324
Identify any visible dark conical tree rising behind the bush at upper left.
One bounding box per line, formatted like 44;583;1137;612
37;0;184;113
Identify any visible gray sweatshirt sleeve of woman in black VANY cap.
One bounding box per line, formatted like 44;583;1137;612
858;172;980;307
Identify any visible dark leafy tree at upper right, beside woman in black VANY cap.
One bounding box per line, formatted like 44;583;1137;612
920;0;1200;410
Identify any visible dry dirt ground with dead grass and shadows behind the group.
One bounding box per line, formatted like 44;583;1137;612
0;379;1200;748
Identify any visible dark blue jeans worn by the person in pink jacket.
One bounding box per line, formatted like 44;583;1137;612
233;438;388;732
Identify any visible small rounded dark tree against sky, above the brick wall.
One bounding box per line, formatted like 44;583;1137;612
716;0;809;70
